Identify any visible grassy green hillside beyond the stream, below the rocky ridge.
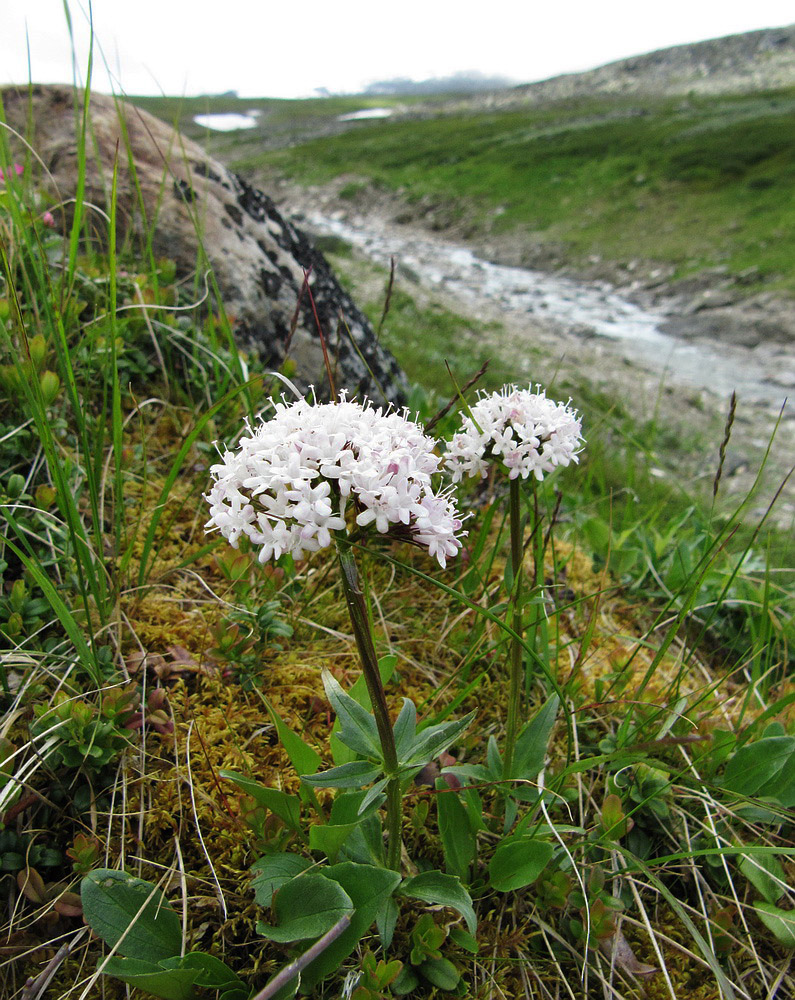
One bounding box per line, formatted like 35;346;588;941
160;90;795;290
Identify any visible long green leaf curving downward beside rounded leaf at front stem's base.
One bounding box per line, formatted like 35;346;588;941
300;861;400;993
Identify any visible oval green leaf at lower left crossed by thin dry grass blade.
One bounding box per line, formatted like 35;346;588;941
80;868;182;962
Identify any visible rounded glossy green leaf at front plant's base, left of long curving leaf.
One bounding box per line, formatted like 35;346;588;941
257;872;353;942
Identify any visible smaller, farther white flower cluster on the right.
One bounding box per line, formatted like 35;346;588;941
445;385;583;483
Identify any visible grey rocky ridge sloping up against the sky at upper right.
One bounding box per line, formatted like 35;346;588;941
511;24;795;103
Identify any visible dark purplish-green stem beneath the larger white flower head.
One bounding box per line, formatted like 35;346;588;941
335;531;403;871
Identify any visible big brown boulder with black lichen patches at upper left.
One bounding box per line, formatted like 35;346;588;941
2;86;406;403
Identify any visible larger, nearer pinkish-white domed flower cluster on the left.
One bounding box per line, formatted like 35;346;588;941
205;398;462;566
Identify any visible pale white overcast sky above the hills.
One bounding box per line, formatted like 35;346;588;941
0;0;795;97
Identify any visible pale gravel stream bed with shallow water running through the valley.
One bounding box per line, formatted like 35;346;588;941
282;186;795;529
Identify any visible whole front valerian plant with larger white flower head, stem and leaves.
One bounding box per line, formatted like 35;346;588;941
207;394;475;989
